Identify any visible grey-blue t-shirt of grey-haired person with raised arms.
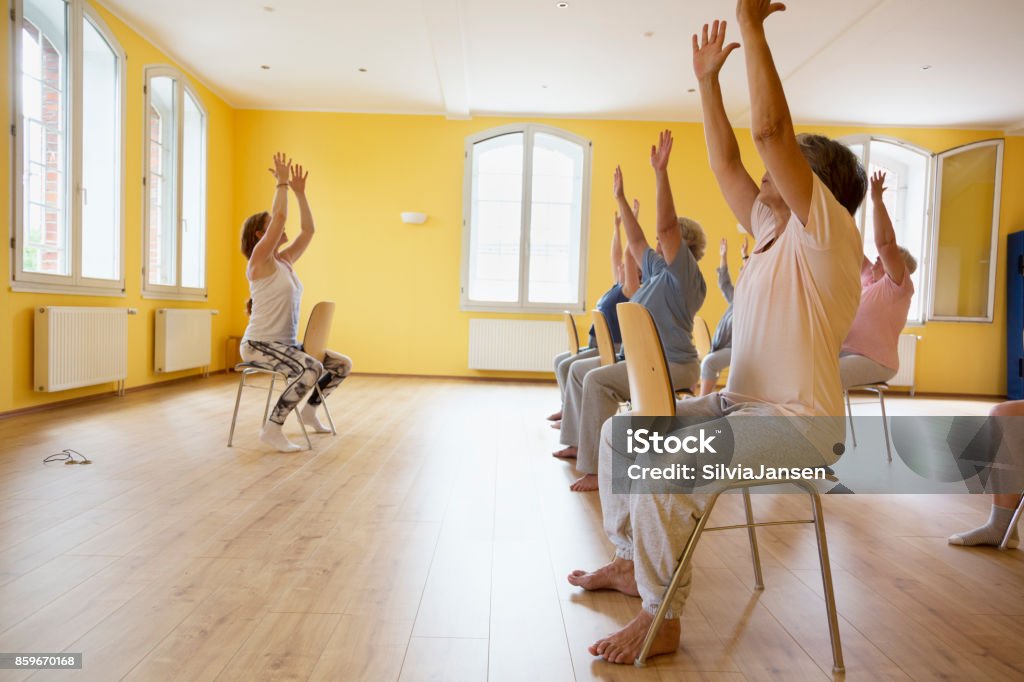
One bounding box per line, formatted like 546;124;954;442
633;244;708;364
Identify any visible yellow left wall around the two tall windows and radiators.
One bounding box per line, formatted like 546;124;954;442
0;2;234;413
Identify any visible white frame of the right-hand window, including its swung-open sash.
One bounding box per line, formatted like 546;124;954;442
839;134;1006;327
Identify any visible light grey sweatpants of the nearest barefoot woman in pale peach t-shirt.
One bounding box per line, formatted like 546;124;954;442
598;393;844;619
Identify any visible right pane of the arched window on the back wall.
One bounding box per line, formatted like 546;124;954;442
527;133;584;304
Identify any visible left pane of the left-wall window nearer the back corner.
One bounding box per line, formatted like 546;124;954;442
146;76;177;287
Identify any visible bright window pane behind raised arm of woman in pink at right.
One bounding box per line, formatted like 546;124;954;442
864;140;931;322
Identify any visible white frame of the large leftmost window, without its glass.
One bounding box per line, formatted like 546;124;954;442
10;0;128;297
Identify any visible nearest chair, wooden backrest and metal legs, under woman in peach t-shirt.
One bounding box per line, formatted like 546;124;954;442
617;303;845;673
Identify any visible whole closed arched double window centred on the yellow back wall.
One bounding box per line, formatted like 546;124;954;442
462;124;591;312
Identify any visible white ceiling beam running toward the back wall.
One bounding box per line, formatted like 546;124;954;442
421;0;471;120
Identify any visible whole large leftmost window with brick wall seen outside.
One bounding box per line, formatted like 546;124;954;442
12;0;124;294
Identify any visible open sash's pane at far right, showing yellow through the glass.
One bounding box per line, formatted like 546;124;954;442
933;144;998;317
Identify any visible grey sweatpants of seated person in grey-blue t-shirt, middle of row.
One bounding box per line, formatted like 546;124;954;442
561;357;700;473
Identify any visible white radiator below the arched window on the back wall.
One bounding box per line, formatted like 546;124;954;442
469;318;566;372
